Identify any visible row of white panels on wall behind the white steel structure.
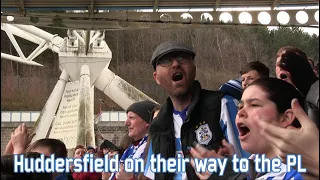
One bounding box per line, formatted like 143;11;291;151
1;111;127;122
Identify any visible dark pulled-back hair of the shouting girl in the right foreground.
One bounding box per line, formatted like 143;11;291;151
249;78;304;127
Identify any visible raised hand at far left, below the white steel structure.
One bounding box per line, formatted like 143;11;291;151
11;123;34;154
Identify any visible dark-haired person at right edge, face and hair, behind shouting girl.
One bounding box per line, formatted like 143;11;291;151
276;46;319;128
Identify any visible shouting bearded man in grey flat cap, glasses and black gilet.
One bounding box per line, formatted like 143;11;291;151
145;41;241;179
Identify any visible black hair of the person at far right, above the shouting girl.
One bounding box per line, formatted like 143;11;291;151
278;46;318;96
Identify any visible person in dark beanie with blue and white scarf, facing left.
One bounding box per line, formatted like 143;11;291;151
111;100;159;179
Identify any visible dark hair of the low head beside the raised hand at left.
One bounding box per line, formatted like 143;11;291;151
26;138;68;158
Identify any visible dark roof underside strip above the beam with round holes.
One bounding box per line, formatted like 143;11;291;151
1;0;319;11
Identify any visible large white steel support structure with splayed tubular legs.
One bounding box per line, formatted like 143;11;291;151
1;23;154;149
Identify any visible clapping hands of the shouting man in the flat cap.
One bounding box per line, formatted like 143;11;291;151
190;139;235;179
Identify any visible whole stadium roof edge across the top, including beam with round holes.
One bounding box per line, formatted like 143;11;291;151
1;0;319;30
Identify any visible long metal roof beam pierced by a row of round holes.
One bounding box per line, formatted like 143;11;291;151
1;9;319;29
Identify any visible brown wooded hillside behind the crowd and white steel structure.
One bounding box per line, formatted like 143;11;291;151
1;26;319;112
